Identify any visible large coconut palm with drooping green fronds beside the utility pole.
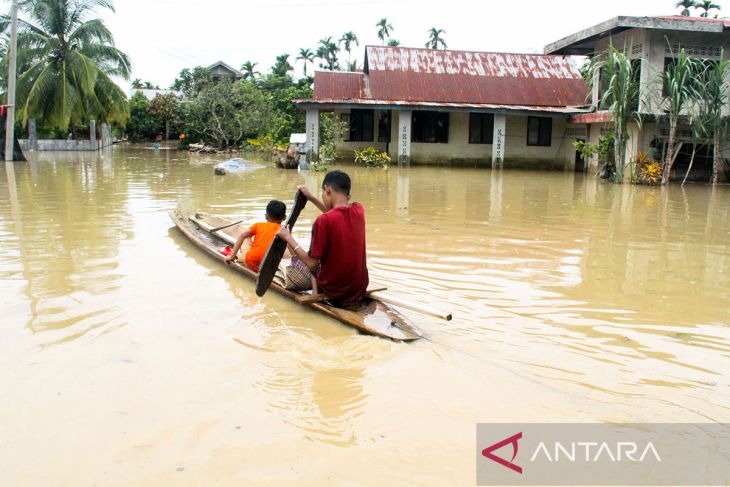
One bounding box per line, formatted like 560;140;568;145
17;0;131;131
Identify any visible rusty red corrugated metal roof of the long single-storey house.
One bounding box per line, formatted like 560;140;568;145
314;46;588;107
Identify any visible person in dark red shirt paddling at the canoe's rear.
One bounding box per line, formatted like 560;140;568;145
278;171;369;305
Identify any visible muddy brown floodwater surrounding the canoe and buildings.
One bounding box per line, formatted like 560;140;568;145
0;147;730;486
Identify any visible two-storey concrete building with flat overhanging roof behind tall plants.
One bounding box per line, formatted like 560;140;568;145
545;16;730;181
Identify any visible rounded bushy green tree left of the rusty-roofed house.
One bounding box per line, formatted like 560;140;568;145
181;81;272;149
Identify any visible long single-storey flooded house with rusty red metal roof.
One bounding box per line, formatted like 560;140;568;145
295;46;591;168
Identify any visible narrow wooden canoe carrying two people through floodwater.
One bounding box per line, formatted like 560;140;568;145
169;210;423;341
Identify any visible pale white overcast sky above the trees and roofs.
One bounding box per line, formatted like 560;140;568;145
8;0;730;89
